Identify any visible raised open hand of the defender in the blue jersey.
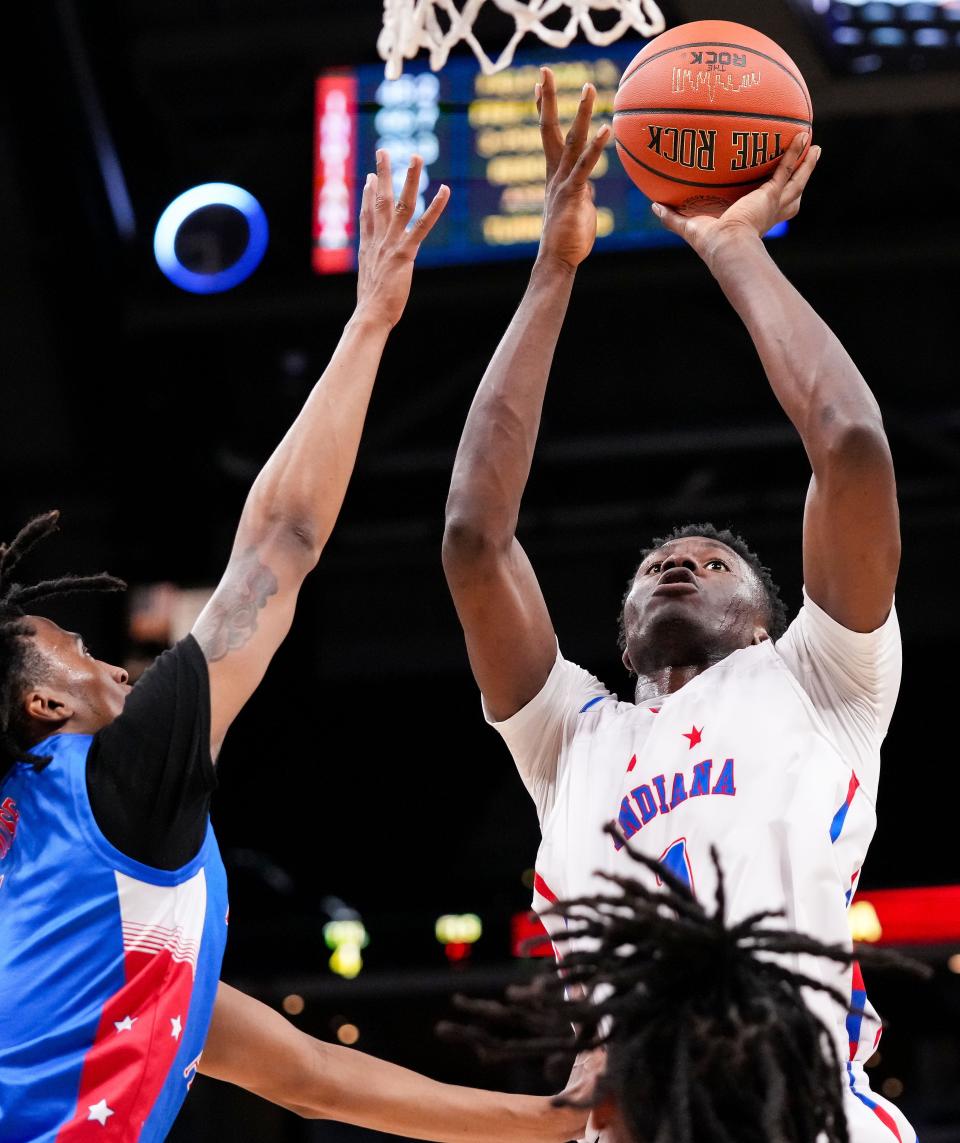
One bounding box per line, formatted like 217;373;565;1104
357;150;450;327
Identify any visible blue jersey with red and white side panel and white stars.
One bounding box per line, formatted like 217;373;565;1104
0;734;227;1143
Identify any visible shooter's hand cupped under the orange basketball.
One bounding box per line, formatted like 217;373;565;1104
654;131;821;272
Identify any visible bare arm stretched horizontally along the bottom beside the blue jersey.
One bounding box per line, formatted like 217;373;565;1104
200;983;586;1143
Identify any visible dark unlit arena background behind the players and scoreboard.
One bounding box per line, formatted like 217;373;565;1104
0;0;960;1143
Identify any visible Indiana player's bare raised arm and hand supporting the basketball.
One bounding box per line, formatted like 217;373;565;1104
655;138;901;631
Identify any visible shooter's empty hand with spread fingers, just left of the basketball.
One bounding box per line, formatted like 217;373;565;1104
536;67;610;267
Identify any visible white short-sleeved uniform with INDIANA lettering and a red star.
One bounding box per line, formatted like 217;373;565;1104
488;593;915;1143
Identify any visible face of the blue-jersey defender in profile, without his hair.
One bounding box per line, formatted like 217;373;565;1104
22;615;133;744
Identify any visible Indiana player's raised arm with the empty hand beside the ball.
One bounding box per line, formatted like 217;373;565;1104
443;67;609;720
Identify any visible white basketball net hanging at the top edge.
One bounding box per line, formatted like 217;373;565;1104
377;0;666;79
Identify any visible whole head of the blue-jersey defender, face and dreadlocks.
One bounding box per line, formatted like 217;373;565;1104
0;512;130;778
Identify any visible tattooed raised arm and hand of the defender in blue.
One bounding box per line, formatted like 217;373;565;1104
193;151;449;756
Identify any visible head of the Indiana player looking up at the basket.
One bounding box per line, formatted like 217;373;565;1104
621;523;786;678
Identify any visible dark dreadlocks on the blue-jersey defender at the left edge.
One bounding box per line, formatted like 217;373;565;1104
0;511;127;781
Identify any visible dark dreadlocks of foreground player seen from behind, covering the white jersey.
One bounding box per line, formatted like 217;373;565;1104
441;825;917;1143
